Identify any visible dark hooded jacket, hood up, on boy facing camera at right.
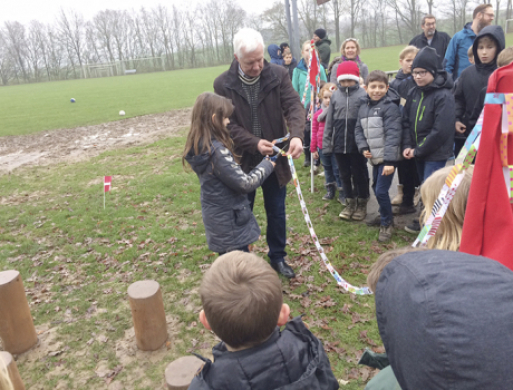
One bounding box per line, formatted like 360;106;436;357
454;26;506;138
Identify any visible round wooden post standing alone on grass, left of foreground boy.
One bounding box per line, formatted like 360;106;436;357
128;280;167;351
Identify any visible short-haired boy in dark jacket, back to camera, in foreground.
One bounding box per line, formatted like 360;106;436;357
189;251;339;390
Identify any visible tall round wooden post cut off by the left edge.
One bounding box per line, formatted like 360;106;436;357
0;270;37;354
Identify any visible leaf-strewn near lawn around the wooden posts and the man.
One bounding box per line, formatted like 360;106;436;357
0;132;413;390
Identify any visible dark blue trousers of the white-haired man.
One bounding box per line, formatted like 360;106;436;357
248;172;287;263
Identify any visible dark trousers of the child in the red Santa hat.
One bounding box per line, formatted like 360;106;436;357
335;153;369;199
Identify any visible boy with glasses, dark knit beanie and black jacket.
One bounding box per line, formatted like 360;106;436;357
403;47;456;233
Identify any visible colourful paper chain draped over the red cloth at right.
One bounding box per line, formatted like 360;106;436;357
412;93;513;247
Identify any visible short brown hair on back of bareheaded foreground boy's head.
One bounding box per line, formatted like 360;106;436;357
200;251;283;348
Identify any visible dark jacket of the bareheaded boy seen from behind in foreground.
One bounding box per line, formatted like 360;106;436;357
189;317;339;390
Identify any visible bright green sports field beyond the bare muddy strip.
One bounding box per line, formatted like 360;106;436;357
0;33;513;136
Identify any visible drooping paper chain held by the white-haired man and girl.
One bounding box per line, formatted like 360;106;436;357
273;134;372;295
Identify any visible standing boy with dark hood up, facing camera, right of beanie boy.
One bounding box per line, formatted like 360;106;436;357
454;26;506;156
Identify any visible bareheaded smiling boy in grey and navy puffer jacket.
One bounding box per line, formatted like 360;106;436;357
355;70;402;242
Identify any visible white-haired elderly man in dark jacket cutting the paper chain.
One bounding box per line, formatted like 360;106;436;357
214;28;305;278
